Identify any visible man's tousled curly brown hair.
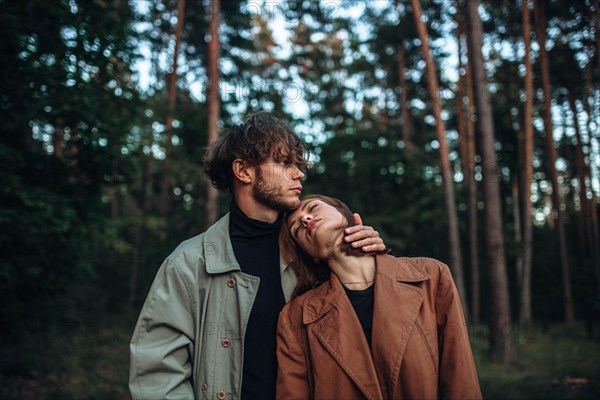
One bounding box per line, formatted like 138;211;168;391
203;113;308;190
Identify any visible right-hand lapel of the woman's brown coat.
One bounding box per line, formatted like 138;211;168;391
372;255;430;398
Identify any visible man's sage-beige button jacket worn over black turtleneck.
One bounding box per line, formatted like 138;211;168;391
129;214;296;400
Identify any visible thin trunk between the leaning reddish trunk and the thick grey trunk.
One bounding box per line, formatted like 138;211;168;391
456;0;479;323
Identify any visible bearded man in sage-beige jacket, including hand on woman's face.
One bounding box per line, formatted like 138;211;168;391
129;115;385;400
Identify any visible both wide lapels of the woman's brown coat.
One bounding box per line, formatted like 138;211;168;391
303;255;430;399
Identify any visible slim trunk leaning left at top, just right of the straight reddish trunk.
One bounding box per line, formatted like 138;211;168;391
535;0;575;323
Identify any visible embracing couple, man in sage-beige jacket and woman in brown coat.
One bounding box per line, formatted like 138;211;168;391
129;115;481;400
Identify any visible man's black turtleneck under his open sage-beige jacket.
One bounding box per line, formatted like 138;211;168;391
229;201;285;400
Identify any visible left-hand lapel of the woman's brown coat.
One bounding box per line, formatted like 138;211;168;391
303;274;383;400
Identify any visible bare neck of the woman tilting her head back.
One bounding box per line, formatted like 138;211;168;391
328;253;375;290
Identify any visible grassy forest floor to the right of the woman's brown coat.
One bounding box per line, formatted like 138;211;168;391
470;325;600;399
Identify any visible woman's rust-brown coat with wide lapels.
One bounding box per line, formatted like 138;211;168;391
277;255;481;400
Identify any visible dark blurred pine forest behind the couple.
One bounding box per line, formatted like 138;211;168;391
0;0;600;399
